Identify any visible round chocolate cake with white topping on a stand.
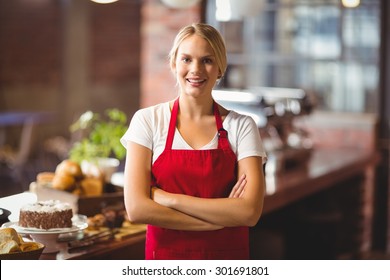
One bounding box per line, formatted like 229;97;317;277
19;200;73;229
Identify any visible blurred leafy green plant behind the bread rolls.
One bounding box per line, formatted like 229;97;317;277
69;108;127;163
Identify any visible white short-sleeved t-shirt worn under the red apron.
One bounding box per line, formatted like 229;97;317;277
121;102;266;163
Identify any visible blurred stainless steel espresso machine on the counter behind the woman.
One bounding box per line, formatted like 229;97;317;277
213;87;314;174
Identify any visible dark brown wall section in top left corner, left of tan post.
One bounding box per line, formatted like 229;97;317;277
0;0;62;87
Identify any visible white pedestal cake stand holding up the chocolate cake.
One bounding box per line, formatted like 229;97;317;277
2;215;88;253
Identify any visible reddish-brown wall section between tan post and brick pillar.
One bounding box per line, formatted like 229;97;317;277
90;0;141;85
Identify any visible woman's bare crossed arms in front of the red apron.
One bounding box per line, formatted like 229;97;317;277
124;142;264;231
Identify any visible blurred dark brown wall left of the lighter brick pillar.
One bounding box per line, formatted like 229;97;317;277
0;0;141;142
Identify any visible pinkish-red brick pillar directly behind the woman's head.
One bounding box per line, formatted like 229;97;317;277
140;0;202;107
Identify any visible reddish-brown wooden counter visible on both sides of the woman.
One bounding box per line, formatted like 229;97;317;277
42;149;379;259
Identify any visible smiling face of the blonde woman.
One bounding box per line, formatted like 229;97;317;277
172;34;221;99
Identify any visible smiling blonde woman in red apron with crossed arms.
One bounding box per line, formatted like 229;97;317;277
121;24;266;259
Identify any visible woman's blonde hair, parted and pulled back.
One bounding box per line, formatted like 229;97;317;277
168;23;227;78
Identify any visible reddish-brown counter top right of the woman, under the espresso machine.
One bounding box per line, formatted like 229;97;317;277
263;148;379;215
